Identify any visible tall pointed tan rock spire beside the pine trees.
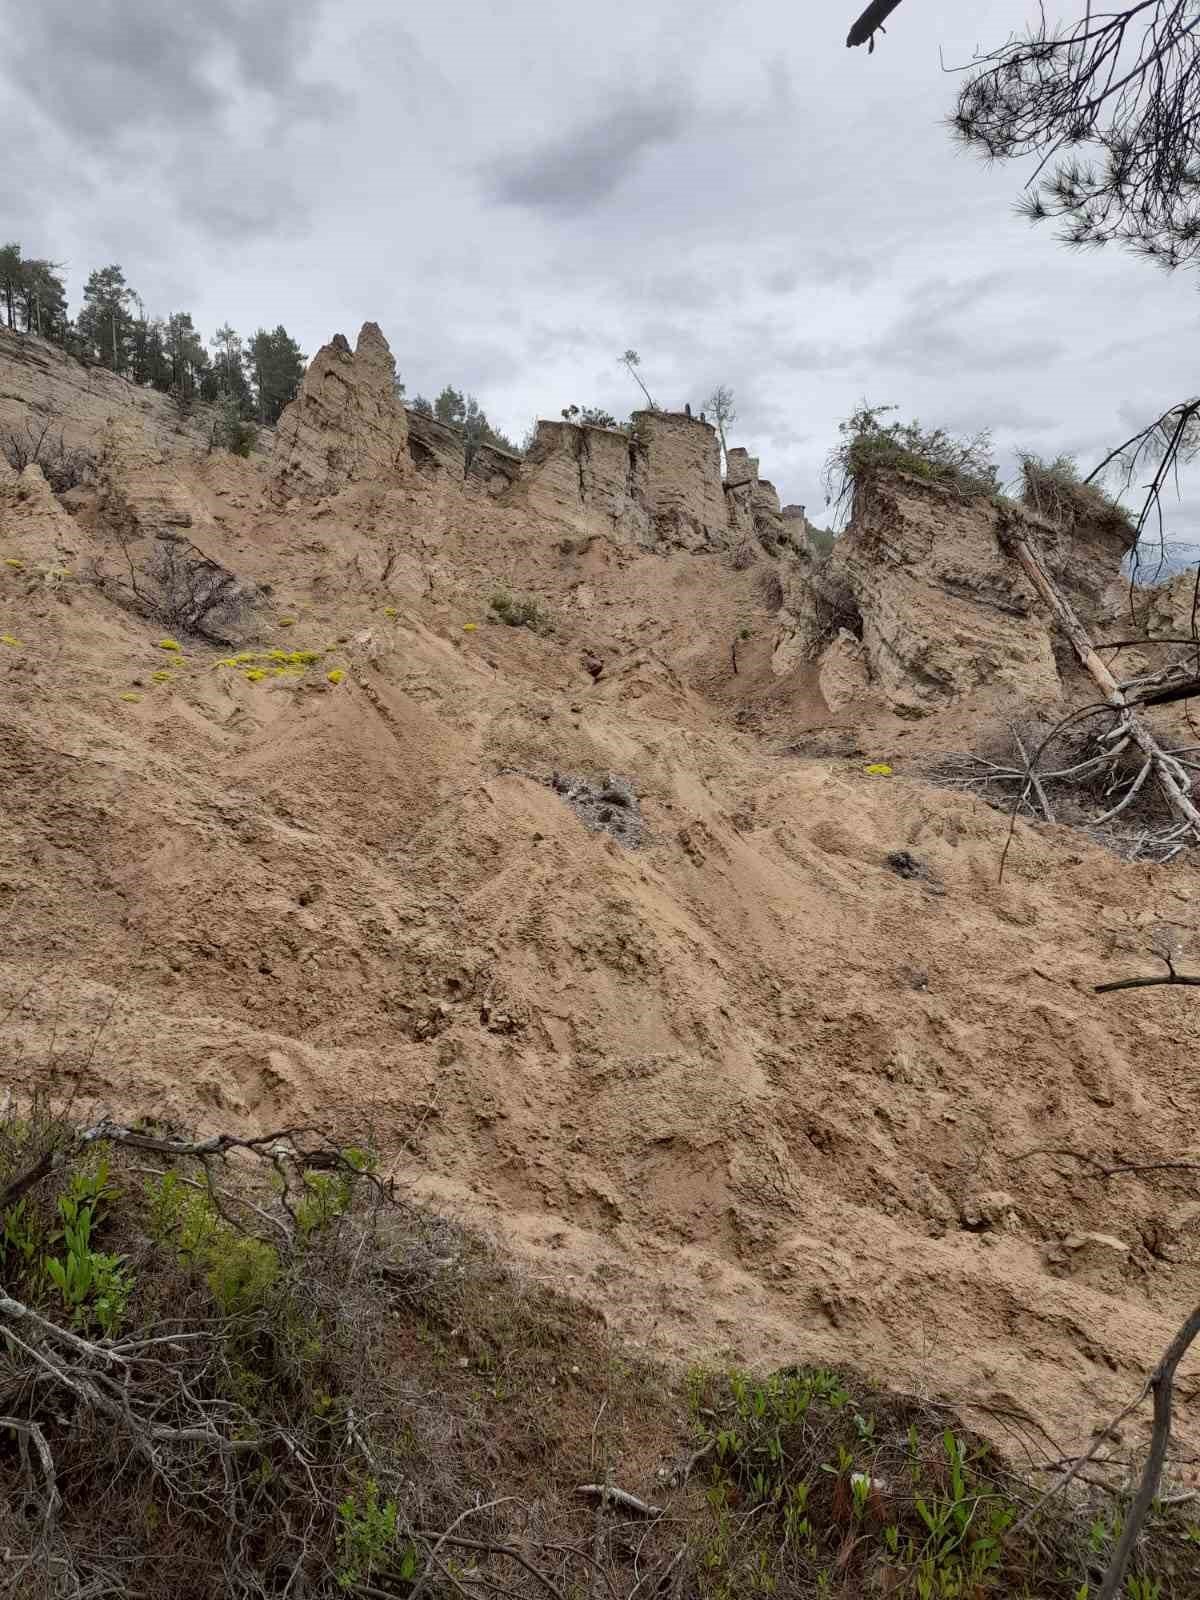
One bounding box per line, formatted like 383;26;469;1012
272;322;411;501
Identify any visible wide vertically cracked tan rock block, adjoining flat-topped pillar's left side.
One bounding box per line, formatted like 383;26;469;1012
507;422;651;544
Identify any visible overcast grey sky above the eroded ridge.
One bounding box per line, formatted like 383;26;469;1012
0;0;1200;538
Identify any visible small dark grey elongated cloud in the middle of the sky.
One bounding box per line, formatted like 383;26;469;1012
483;88;690;214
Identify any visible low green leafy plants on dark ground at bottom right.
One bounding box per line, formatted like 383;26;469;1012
688;1368;1126;1600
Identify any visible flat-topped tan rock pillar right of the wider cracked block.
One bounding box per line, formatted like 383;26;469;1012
634;411;730;550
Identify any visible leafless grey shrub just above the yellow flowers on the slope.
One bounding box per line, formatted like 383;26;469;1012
94;534;261;645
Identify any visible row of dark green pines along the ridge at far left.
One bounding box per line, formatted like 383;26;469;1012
0;243;307;424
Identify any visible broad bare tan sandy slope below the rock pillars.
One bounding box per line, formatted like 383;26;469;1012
0;444;1200;1478
